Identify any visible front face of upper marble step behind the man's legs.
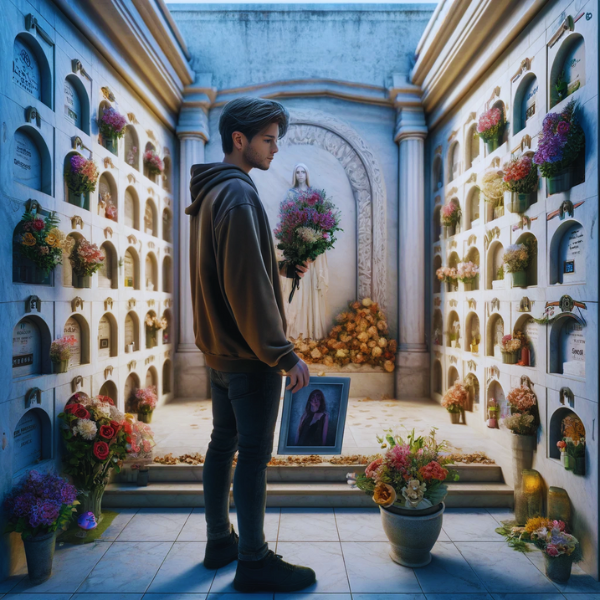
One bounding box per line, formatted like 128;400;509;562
134;464;504;483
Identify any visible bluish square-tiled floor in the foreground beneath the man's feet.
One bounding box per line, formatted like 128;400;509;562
0;508;600;600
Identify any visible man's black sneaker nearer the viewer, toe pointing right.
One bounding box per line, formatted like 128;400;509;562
233;550;317;592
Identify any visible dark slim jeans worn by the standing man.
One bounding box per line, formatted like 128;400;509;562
203;369;283;560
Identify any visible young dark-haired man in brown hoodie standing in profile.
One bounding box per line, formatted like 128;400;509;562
185;97;316;592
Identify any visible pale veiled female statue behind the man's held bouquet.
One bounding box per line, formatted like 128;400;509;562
282;163;329;340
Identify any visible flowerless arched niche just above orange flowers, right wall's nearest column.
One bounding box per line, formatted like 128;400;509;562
550;313;585;377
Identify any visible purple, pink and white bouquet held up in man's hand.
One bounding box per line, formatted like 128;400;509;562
274;188;343;302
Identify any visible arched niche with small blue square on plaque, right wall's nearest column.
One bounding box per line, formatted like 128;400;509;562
550;220;587;285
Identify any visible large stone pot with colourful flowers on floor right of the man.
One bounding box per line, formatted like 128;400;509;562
347;429;458;567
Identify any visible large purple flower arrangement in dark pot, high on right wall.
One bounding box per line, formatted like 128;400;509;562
533;100;585;195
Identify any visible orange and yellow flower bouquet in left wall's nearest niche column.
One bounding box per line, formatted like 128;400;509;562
16;211;73;275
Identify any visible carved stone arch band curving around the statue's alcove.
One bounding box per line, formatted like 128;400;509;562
282;110;387;310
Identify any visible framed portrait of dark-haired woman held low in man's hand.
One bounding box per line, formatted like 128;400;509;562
277;377;350;454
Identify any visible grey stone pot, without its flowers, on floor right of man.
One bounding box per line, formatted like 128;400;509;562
379;502;446;568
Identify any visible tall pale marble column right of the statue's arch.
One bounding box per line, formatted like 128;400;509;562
394;105;430;398
